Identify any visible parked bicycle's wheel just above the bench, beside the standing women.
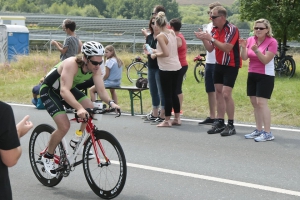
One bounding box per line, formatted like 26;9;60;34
127;61;148;83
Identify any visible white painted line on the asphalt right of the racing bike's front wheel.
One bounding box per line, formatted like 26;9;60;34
127;163;300;196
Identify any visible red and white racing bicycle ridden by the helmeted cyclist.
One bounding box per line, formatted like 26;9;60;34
29;108;127;199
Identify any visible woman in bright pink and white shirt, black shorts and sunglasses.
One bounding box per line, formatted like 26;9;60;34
239;19;278;142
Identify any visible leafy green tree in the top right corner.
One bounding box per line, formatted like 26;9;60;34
239;0;300;45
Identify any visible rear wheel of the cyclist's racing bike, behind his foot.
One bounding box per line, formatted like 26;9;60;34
29;124;64;187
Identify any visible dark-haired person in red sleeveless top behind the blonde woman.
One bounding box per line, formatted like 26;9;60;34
170;18;188;114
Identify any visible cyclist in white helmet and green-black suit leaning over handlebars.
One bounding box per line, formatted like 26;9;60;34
40;41;120;177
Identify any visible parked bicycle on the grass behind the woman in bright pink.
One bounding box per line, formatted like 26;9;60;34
274;45;296;78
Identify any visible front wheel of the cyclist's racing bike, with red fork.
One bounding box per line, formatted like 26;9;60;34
83;130;127;199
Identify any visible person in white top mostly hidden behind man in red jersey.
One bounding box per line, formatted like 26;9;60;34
199;2;221;125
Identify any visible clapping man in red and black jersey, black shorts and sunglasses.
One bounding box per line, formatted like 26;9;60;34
195;6;242;136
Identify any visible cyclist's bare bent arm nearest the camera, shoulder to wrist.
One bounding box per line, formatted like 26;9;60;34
59;59;83;111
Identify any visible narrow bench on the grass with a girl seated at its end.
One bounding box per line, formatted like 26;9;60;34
106;86;149;116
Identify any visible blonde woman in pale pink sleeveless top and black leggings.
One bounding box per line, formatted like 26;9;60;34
151;12;181;127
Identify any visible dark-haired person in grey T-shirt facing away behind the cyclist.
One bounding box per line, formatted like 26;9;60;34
51;19;82;61
